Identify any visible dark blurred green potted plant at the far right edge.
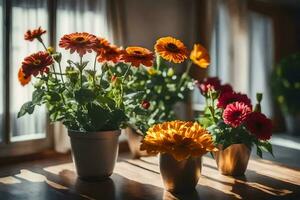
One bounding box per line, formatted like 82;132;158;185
272;53;300;135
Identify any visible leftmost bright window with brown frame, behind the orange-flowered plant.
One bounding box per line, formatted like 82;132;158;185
0;0;51;156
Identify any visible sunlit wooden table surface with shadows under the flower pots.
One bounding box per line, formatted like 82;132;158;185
0;154;300;200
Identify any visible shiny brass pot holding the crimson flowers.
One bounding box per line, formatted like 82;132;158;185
213;144;251;176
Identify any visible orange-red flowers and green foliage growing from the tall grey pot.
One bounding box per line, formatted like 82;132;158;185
18;27;154;132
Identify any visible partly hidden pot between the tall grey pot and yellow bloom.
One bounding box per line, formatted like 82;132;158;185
124;127;149;158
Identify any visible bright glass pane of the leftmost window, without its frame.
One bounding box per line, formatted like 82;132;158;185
10;0;48;141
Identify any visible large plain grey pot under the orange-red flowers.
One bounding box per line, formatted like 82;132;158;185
68;130;120;180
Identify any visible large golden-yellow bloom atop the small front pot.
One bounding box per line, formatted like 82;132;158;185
141;121;217;161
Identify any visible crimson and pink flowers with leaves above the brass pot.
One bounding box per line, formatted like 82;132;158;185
197;77;273;157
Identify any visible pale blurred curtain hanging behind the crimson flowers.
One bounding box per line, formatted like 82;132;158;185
209;0;273;116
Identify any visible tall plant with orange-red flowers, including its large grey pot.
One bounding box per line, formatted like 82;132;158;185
18;28;153;180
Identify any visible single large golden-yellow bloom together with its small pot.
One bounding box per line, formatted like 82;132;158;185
141;121;217;193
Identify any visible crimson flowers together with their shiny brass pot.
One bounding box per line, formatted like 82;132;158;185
197;77;273;176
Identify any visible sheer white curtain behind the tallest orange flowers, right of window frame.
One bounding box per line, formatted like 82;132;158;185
54;0;113;152
